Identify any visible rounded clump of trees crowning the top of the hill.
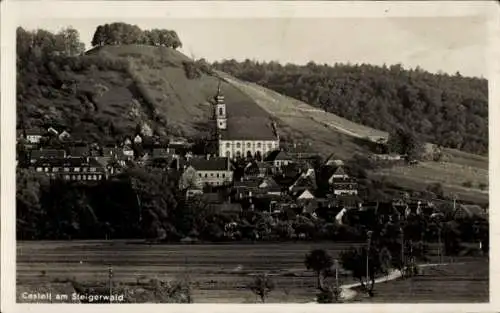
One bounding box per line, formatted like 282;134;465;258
92;23;182;49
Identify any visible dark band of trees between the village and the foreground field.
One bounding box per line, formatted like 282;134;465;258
16;161;487;243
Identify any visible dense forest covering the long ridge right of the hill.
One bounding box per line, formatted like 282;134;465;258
213;60;488;154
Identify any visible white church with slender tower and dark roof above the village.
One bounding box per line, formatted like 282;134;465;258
214;81;279;160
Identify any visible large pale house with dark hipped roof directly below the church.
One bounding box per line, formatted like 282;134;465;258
183;156;233;188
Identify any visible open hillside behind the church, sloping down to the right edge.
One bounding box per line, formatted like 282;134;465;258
18;41;488;201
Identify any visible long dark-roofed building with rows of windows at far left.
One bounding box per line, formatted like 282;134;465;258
31;158;106;181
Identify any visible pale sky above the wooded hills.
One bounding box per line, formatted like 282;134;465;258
18;16;488;77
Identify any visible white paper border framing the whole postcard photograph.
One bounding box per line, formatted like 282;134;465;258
0;0;500;313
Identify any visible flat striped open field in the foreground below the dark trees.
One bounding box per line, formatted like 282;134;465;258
17;241;487;303
